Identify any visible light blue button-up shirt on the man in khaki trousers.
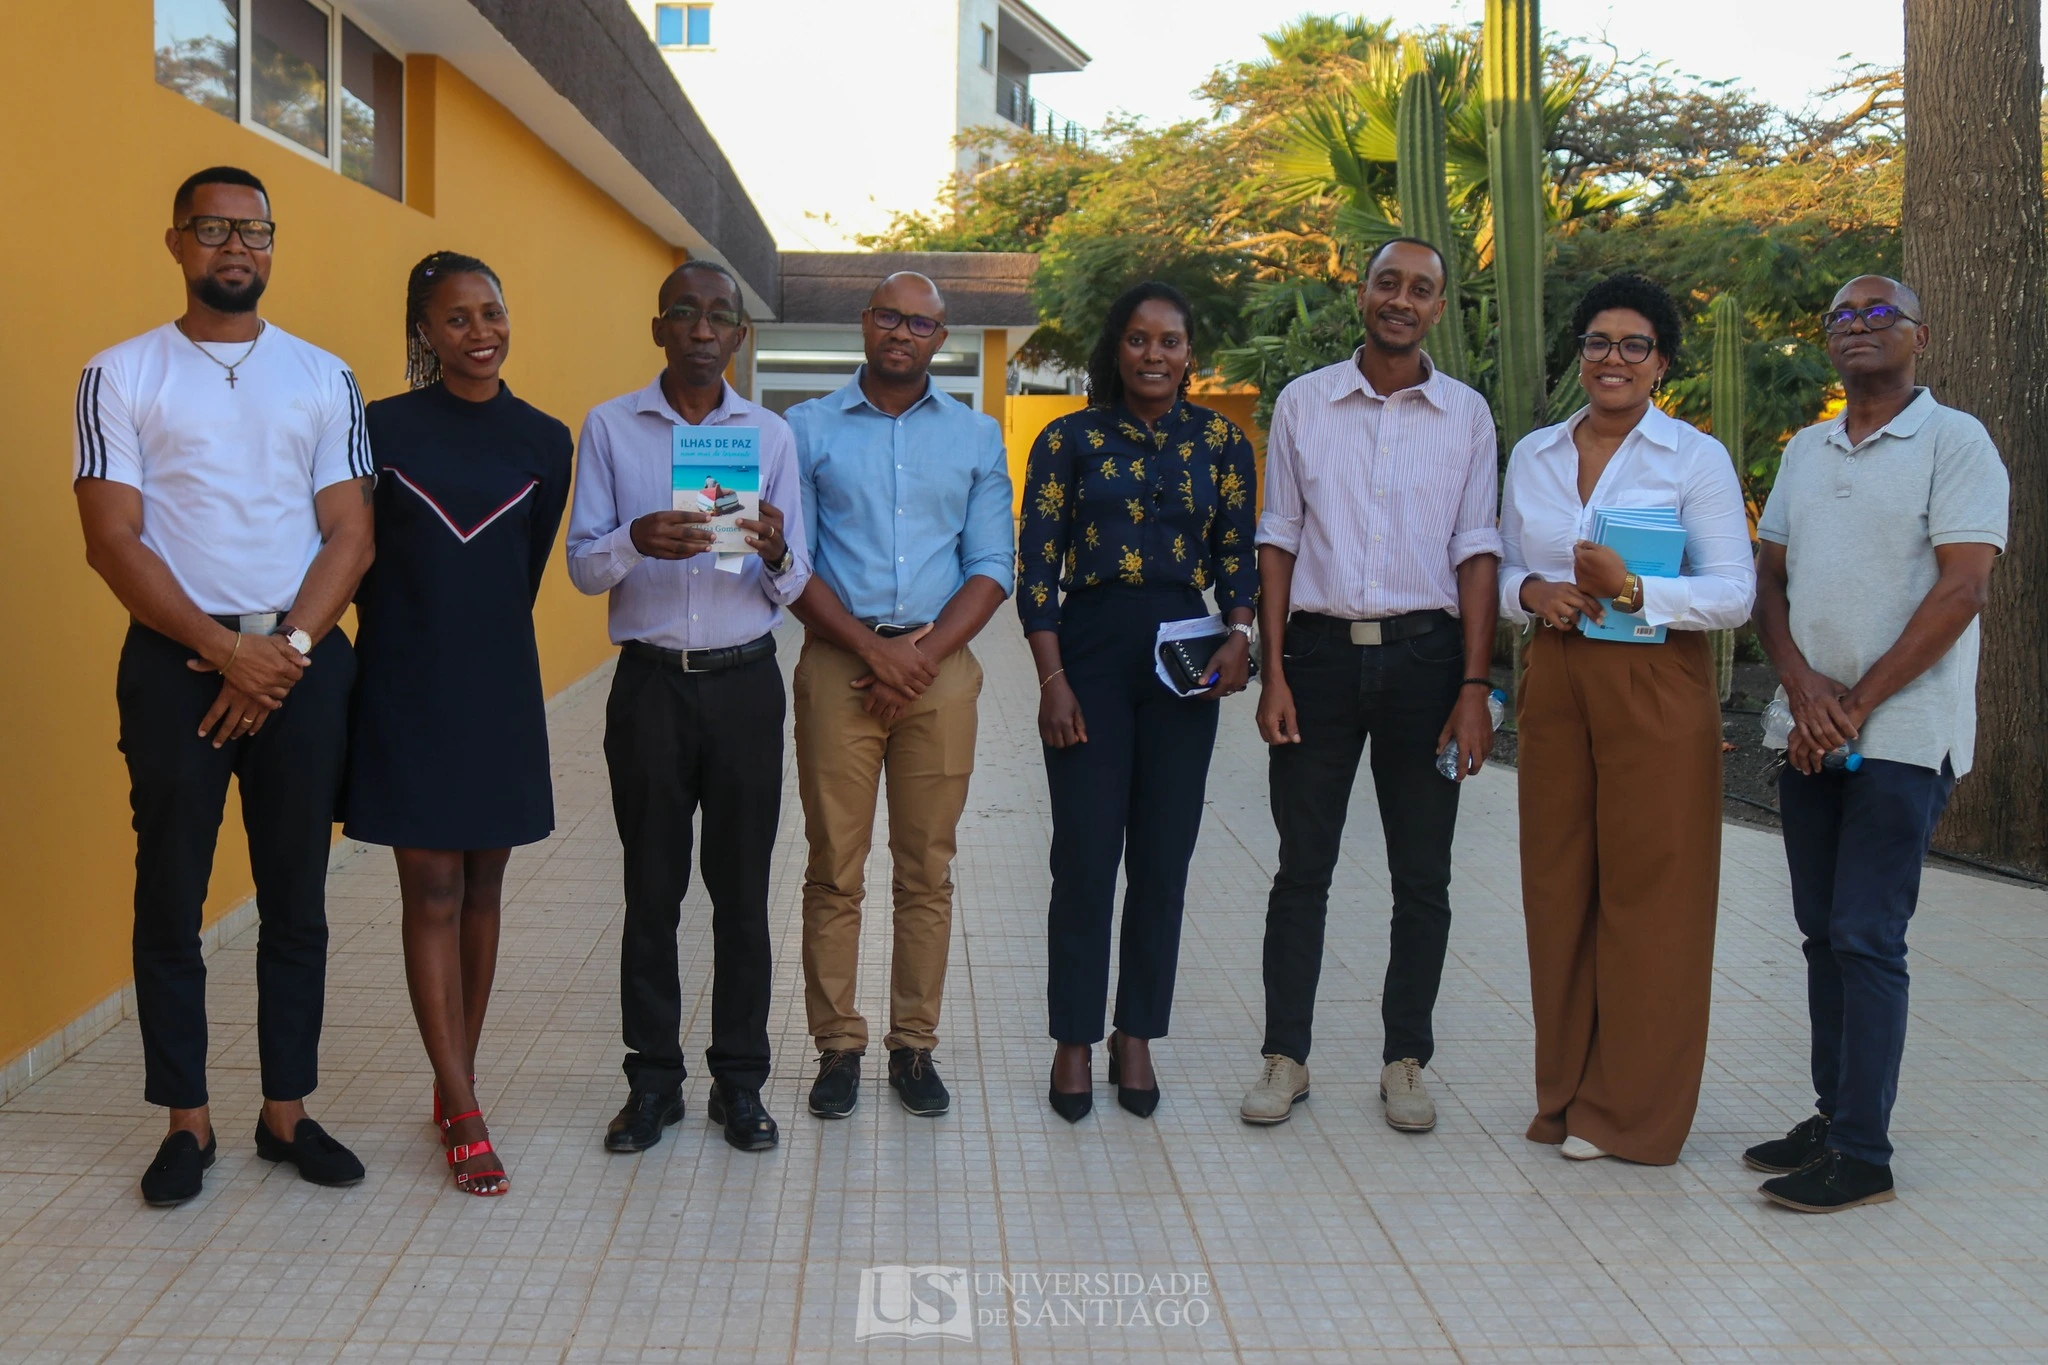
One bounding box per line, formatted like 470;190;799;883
788;366;1016;626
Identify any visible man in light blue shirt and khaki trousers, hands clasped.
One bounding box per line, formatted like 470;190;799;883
788;272;1016;1119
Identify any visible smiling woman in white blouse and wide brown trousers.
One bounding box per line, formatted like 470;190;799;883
1501;274;1755;1164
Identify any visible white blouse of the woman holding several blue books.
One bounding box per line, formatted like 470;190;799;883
1501;405;1757;630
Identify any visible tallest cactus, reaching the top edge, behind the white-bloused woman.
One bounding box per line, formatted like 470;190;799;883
1481;0;1550;450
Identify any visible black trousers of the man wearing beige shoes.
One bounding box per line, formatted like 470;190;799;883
1264;616;1464;1064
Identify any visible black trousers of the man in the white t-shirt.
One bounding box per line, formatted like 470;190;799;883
115;624;356;1109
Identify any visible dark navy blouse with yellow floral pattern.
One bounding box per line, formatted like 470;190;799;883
1018;399;1260;634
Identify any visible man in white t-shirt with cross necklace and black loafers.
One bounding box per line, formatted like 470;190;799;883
74;166;373;1205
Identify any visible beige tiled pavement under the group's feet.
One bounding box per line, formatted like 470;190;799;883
0;614;2048;1365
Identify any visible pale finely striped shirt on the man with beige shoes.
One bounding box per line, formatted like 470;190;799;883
1260;352;1501;620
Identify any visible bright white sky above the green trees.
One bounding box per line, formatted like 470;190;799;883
1030;0;1905;127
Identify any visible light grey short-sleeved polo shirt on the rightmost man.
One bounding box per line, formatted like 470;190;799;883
1757;389;2009;778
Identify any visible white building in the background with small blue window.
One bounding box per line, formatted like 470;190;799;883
631;0;1087;252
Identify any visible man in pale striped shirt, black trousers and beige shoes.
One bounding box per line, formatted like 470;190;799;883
1239;239;1501;1132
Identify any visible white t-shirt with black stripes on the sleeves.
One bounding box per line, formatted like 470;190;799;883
72;323;375;616
